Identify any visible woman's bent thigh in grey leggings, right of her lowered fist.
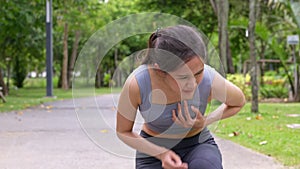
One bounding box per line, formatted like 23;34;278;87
183;143;223;169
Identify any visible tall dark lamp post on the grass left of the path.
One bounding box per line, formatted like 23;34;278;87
46;0;53;97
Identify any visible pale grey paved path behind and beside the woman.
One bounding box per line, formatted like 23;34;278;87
0;95;283;169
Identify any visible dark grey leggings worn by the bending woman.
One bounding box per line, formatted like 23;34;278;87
136;131;223;169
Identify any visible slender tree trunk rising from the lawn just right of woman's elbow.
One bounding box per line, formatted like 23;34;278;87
248;0;258;113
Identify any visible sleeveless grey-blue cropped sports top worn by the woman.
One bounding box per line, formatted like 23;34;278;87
134;65;215;141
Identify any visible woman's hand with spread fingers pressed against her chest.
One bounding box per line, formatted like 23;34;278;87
172;101;206;130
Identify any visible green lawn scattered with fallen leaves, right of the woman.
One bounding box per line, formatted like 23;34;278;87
214;103;300;166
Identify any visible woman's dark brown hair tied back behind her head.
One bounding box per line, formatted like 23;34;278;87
142;25;206;72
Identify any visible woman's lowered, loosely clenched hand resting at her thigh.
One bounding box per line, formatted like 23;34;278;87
160;150;188;169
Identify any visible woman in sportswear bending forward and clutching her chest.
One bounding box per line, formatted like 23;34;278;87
116;25;245;169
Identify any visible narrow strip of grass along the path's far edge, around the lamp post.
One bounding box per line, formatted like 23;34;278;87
0;87;111;112
